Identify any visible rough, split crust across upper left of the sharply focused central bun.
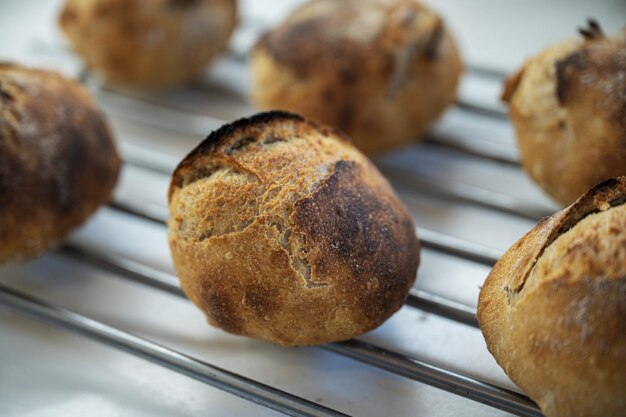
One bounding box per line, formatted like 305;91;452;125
169;111;354;288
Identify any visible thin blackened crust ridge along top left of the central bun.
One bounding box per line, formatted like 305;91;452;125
168;110;306;198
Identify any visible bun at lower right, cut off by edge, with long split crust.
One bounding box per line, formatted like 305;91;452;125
478;177;626;417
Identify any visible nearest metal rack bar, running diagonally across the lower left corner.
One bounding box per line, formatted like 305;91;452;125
0;284;346;417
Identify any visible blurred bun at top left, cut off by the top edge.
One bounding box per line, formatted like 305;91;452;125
59;0;237;88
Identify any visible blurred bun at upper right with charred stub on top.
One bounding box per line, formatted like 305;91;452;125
503;21;626;205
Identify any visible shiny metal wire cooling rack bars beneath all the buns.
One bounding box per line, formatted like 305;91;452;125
0;7;568;416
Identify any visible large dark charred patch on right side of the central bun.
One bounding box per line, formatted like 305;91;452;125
294;161;419;317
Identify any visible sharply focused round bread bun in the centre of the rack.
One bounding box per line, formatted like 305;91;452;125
168;112;419;346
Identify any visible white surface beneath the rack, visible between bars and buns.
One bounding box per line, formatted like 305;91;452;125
0;0;626;416
